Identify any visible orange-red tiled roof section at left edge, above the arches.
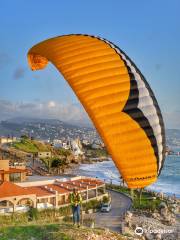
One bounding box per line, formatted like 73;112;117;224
0;181;31;198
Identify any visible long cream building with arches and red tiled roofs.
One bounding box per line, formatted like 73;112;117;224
0;176;107;214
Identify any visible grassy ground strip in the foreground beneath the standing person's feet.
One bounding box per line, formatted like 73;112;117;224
0;223;123;240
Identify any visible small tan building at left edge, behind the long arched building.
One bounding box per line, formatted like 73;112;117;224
0;159;28;182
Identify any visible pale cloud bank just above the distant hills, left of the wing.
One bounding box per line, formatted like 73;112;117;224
0;100;91;125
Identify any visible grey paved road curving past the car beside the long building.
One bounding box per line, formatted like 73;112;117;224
85;191;131;232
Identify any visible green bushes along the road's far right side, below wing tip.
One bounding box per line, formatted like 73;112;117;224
107;184;161;211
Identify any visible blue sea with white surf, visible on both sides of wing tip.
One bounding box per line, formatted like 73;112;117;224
73;155;180;198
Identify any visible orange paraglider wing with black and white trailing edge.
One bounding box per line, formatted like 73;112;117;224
28;34;165;188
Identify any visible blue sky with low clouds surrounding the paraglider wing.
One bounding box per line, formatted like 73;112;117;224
0;0;180;129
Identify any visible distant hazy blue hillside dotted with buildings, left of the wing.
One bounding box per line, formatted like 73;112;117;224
0;118;99;140
